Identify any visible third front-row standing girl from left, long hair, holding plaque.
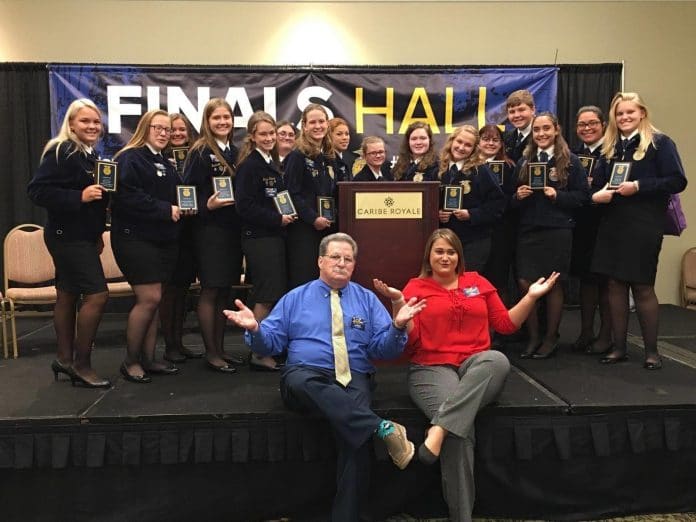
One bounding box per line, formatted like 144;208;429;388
184;98;244;373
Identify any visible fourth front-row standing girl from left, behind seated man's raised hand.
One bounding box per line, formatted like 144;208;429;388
237;111;297;371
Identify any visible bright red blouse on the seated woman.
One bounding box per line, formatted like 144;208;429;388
403;272;517;366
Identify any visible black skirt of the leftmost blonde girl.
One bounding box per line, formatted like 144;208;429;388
44;229;106;295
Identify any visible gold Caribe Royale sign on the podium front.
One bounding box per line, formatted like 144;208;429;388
355;192;423;219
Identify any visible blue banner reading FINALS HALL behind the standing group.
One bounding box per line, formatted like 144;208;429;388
49;65;558;157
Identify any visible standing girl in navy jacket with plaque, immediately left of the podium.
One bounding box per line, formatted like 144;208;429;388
285;103;348;288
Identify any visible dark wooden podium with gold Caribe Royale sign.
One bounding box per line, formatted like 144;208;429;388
338;181;440;292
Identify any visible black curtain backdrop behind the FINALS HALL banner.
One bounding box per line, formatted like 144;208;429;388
0;63;622;286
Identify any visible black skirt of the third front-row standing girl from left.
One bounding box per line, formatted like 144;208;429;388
194;223;243;288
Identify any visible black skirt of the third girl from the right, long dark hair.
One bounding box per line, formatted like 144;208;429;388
516;227;573;282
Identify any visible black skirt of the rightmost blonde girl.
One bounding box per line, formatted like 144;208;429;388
591;198;665;285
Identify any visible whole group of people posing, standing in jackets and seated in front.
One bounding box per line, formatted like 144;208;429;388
28;87;686;520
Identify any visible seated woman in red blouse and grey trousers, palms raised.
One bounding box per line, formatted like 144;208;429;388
375;228;558;521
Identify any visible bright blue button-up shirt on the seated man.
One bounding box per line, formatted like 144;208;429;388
245;279;407;373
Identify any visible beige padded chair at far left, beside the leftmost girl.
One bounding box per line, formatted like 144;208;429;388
2;224;56;358
